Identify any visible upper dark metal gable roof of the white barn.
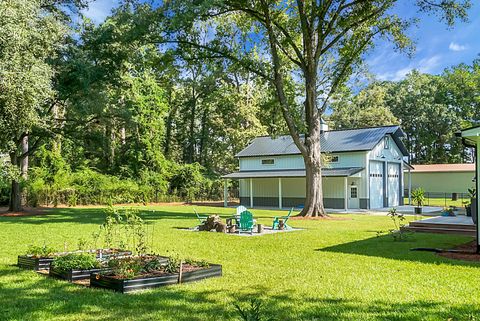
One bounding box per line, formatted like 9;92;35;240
236;126;408;157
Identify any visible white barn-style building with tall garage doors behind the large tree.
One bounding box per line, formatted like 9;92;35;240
223;125;407;210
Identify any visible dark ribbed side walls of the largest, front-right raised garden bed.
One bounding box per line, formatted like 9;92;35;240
90;264;222;293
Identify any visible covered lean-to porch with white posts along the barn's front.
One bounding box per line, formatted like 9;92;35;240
223;167;368;210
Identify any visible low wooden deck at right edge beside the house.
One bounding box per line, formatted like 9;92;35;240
405;215;476;236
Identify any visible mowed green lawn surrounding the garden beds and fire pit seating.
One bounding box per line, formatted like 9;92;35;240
0;206;480;321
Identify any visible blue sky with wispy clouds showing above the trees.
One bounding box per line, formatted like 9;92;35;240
84;0;480;80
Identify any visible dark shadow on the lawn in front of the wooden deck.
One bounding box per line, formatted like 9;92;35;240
316;233;480;267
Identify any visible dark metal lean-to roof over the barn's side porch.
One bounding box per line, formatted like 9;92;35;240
222;167;364;179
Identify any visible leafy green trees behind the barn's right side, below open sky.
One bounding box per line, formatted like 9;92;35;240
330;60;480;164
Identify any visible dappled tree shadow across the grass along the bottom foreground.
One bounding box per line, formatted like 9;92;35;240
0;267;480;321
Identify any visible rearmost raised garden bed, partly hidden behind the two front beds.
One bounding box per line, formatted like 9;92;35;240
17;249;132;271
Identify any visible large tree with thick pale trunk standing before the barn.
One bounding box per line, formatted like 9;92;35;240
158;0;471;216
